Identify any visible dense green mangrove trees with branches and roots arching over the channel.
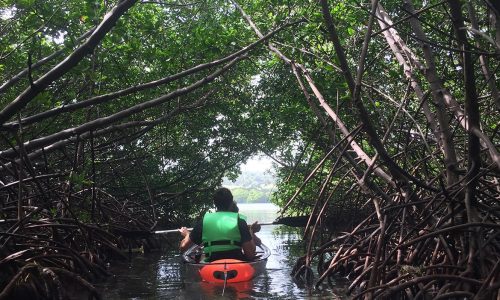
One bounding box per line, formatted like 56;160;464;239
0;0;500;299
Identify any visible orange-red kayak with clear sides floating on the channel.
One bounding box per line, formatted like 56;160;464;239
182;245;271;283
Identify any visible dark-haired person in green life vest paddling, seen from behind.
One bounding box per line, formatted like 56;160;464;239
179;188;260;261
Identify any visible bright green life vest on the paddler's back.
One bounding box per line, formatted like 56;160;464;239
201;211;241;256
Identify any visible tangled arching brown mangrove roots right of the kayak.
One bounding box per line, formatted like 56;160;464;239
308;190;500;299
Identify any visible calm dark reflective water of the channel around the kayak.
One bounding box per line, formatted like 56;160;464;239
99;204;345;300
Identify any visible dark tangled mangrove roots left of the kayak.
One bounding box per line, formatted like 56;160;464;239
0;190;158;300
